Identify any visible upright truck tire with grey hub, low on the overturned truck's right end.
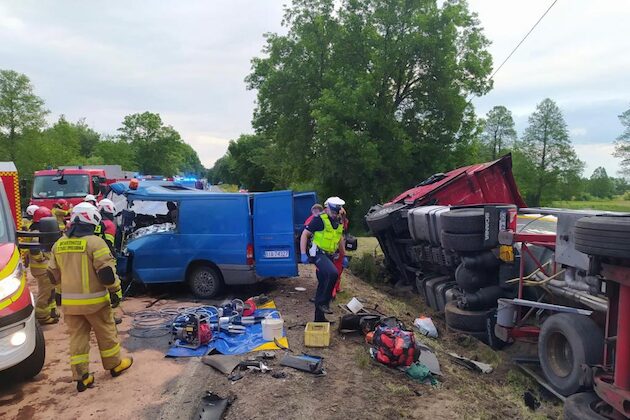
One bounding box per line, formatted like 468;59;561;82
538;313;604;396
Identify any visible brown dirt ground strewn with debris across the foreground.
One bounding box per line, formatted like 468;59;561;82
0;267;561;419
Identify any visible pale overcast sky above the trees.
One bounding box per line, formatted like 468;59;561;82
0;0;630;175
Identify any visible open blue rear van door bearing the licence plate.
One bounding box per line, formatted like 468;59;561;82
252;191;298;277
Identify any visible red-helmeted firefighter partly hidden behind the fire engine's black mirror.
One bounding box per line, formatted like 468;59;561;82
28;207;59;325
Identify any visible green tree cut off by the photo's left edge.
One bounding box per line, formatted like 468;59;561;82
0;70;49;161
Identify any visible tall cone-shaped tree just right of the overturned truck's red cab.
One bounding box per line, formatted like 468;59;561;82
519;98;584;206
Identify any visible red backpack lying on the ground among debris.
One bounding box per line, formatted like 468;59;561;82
373;325;416;367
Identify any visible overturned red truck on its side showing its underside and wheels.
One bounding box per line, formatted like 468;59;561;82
365;155;630;407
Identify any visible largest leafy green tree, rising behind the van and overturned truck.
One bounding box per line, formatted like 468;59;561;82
247;0;492;221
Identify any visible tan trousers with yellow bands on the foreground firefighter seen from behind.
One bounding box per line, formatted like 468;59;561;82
64;306;120;381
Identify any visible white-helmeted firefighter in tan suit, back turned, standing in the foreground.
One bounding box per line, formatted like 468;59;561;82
48;203;133;392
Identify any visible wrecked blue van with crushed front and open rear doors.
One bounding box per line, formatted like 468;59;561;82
112;183;317;298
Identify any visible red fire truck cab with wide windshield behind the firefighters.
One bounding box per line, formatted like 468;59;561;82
30;169;107;209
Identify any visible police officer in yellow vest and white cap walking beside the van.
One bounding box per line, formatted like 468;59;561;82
300;197;345;322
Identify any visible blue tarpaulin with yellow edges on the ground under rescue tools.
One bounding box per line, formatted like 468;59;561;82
166;301;289;357
